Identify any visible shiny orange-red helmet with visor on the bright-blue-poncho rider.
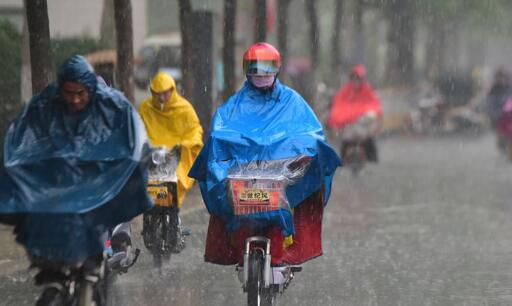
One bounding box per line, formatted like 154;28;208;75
243;42;281;75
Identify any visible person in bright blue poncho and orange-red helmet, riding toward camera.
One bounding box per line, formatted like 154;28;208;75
190;43;340;264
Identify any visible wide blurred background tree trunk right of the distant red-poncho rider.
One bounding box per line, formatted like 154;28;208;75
386;0;415;85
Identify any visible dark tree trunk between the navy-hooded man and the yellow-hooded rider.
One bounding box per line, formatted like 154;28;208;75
114;0;135;103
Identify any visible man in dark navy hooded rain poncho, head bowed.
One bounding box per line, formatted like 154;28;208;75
0;55;152;262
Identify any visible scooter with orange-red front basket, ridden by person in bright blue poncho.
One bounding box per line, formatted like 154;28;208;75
227;158;307;306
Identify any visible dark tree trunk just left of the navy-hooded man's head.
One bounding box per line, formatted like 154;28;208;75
25;0;54;94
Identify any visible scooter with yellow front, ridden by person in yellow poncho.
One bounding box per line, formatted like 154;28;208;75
142;146;189;267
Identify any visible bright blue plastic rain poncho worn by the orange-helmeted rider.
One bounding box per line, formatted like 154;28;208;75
189;80;341;236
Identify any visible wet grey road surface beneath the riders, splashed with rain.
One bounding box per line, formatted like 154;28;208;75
0;133;512;306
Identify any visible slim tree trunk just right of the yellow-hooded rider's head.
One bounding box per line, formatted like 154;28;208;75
178;0;194;96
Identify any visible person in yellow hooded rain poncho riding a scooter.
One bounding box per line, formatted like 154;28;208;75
139;72;203;208
